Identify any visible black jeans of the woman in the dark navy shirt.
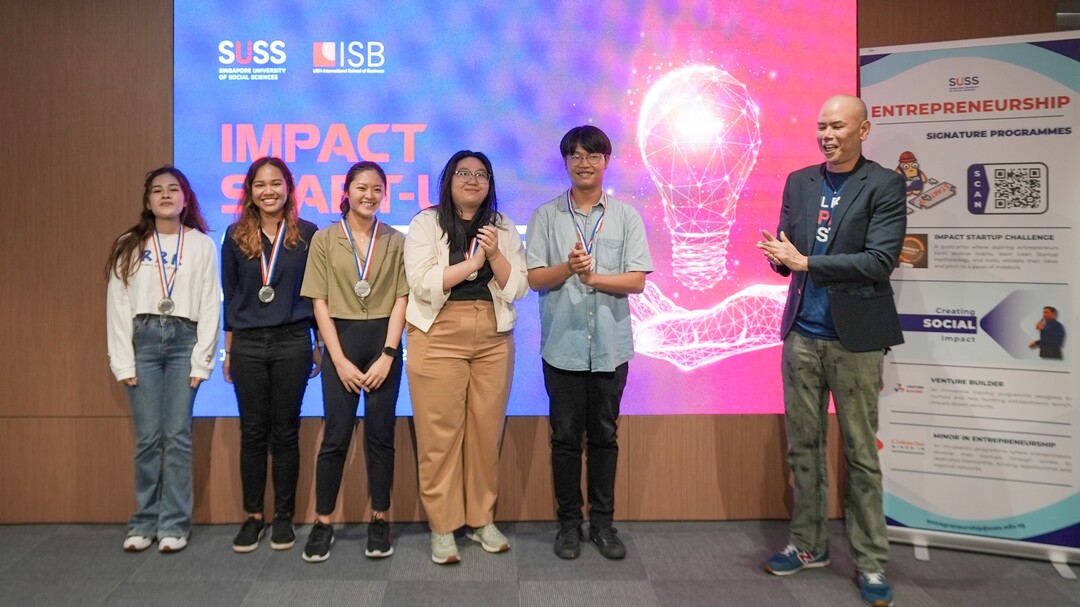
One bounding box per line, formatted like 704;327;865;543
229;321;311;517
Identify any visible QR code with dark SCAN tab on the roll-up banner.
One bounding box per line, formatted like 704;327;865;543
968;162;1049;215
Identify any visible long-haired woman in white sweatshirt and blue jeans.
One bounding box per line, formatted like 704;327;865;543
106;165;221;552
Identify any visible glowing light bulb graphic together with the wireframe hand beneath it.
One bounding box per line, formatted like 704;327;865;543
630;66;787;370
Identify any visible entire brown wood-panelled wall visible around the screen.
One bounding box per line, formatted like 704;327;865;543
0;0;1055;523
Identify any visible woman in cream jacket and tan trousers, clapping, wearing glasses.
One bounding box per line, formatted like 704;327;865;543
405;150;528;565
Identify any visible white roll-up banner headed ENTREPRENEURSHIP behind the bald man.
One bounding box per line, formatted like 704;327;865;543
860;32;1080;563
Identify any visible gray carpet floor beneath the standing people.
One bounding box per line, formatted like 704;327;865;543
0;521;1080;607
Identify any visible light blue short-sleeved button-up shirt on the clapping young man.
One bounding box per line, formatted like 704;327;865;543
525;192;652;372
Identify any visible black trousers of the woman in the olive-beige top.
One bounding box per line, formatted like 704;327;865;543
315;319;402;515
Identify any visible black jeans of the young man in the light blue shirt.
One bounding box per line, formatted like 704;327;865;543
543;361;630;527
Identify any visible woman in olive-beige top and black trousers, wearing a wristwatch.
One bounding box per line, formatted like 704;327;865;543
300;161;408;563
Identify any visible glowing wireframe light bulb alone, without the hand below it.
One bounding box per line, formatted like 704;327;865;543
637;65;761;291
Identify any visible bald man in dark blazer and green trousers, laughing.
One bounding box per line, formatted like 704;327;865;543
758;95;907;607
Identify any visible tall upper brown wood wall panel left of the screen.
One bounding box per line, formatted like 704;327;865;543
0;0;173;416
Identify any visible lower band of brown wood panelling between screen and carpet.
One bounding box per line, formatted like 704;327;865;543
0;416;812;523
